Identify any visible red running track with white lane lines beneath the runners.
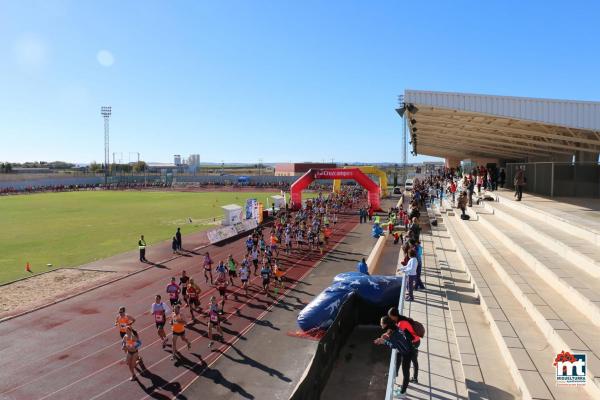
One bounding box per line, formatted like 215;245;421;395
0;211;357;400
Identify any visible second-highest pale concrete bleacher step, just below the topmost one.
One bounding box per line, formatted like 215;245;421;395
485;202;600;278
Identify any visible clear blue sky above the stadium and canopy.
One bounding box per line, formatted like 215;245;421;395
0;0;600;162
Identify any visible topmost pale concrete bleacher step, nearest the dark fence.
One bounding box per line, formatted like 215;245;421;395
495;193;600;246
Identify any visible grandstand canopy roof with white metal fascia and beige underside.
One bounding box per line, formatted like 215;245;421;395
397;90;600;160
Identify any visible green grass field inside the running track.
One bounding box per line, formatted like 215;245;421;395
0;192;278;283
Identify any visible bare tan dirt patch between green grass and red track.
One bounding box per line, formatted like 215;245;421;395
0;268;123;319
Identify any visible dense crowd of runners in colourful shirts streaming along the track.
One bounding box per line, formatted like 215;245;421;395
115;188;366;380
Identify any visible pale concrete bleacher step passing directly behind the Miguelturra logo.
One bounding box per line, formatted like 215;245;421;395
454;211;600;398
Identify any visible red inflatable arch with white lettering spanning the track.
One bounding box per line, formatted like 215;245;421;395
290;168;381;211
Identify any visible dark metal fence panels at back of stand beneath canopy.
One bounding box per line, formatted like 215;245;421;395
506;162;600;198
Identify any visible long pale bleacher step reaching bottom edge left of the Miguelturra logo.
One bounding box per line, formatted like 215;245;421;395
447;217;594;399
